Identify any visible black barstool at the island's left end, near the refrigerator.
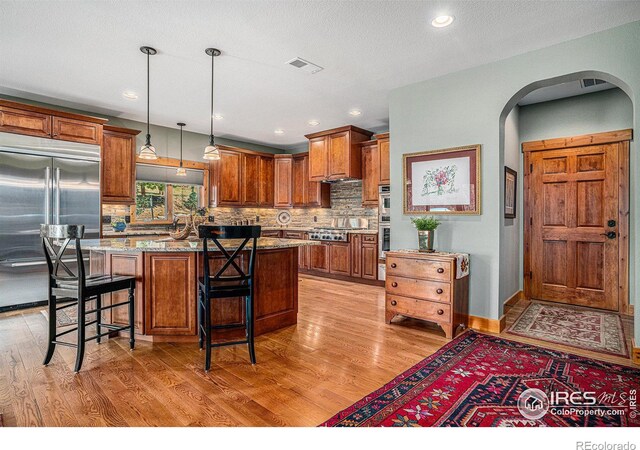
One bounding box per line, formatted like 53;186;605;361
40;225;136;373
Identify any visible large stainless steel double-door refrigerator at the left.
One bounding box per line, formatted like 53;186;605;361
0;133;100;311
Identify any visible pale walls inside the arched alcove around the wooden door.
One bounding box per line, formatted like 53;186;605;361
499;71;638;314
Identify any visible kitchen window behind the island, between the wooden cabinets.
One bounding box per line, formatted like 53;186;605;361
132;181;203;223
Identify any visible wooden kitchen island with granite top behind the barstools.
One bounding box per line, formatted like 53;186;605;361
82;237;316;342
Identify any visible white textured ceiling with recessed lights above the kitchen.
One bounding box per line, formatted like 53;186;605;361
0;0;640;148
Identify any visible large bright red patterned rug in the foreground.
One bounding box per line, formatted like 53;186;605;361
321;330;640;427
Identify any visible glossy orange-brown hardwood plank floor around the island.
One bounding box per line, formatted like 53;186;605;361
0;276;629;426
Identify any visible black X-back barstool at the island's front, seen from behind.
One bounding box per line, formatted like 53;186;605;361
198;225;260;371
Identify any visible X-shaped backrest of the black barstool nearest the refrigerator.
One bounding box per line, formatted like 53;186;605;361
40;224;85;287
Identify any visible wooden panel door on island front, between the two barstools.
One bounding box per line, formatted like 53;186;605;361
144;252;196;336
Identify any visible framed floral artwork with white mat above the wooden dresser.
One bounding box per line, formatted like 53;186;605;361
402;145;480;215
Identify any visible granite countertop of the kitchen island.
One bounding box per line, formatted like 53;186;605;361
82;237;319;252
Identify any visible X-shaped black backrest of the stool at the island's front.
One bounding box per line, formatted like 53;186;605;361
198;225;261;286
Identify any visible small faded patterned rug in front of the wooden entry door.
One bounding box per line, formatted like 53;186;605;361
507;302;629;358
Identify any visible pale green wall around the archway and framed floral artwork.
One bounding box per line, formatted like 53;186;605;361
389;22;640;341
